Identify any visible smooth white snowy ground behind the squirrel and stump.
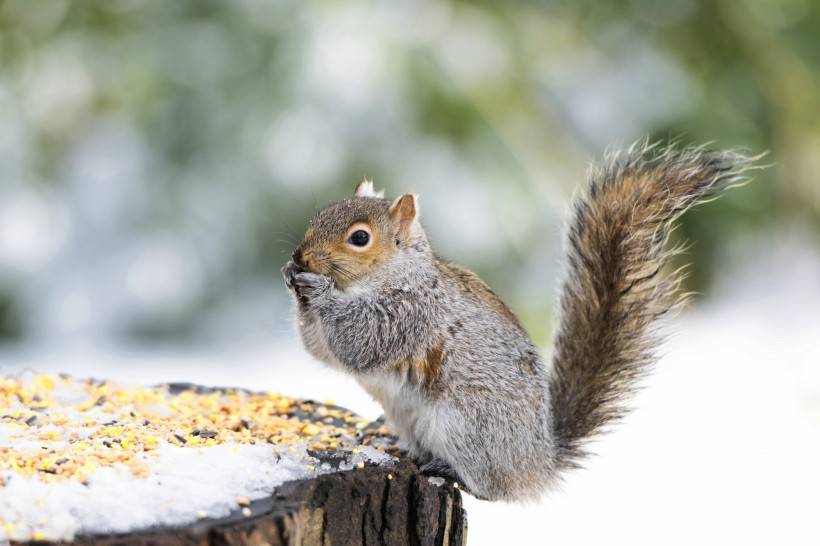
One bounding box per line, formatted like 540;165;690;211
0;239;820;546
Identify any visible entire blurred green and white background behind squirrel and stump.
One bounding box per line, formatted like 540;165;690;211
0;0;820;544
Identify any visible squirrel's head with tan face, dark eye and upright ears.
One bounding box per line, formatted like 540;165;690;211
293;180;425;290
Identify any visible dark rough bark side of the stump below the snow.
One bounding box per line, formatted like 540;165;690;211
0;378;467;546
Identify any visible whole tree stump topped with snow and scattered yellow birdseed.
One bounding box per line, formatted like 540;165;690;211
0;374;466;546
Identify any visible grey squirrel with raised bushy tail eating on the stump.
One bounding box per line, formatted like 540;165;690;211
282;141;753;500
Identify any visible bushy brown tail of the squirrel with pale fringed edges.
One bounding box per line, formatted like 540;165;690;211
550;143;754;470
